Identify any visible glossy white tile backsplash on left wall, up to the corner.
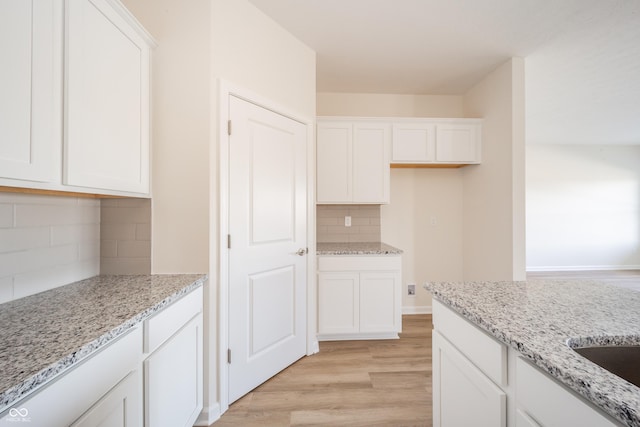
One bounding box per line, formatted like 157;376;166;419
0;193;100;303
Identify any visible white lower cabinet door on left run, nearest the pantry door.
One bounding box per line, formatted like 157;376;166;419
144;314;203;427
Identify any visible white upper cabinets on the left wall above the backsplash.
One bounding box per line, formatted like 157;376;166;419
0;0;154;196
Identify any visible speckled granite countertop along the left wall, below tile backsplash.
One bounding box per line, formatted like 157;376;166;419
0;274;206;412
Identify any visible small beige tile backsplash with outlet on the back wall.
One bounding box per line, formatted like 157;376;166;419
316;205;380;243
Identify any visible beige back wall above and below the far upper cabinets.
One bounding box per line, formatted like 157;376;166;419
317;93;464;313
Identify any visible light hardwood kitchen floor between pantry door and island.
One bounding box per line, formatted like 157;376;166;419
213;315;432;427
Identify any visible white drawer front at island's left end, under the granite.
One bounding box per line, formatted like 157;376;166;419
433;300;507;386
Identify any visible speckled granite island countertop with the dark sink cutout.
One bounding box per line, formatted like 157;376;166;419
425;280;640;426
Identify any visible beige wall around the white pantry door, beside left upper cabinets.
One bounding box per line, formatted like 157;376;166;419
124;0;315;424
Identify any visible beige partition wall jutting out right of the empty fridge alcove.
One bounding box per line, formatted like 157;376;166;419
463;58;525;280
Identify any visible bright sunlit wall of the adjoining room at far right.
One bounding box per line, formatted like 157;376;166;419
526;144;640;271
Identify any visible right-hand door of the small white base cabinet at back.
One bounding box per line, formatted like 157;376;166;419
360;273;402;332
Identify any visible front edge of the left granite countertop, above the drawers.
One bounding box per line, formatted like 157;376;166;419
0;274;208;413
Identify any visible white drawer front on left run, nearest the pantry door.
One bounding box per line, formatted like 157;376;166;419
144;287;203;353
